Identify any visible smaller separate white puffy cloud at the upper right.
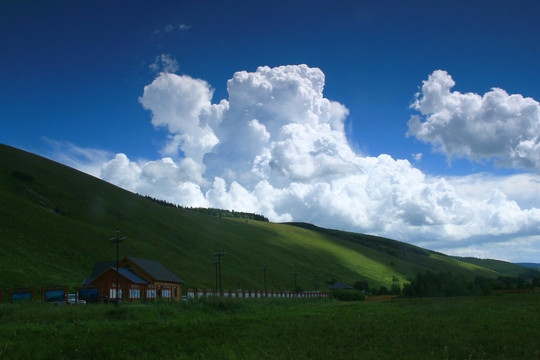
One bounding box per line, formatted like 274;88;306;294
407;70;540;172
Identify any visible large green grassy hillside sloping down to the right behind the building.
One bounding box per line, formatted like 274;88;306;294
0;145;532;296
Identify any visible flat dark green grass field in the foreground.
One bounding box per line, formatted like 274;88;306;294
0;295;540;359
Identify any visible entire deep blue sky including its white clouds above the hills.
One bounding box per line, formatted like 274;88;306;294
0;1;540;262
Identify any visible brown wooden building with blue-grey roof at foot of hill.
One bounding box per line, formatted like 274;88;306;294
83;256;184;302
